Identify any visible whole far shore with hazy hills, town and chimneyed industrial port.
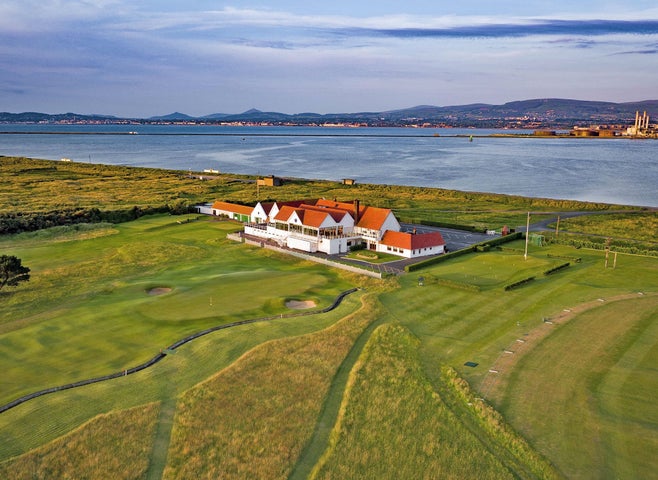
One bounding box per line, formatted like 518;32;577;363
0;99;658;138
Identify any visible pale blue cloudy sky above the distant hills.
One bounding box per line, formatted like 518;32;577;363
0;0;658;118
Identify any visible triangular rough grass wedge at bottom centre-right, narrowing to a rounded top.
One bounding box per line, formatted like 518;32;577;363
311;324;514;479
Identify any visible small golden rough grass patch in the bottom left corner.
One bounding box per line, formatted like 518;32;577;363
0;403;159;480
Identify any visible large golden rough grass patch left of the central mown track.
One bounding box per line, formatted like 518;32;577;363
164;290;374;479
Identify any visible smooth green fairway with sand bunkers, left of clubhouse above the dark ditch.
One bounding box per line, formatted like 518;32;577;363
0;216;351;403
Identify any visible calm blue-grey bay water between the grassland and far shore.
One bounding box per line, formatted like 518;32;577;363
0;124;658;207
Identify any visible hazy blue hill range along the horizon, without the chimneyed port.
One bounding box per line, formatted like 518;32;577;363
0;98;658;128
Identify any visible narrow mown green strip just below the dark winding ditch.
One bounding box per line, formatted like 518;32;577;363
0;288;359;459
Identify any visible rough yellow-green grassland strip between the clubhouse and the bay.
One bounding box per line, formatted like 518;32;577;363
0;157;637;228
